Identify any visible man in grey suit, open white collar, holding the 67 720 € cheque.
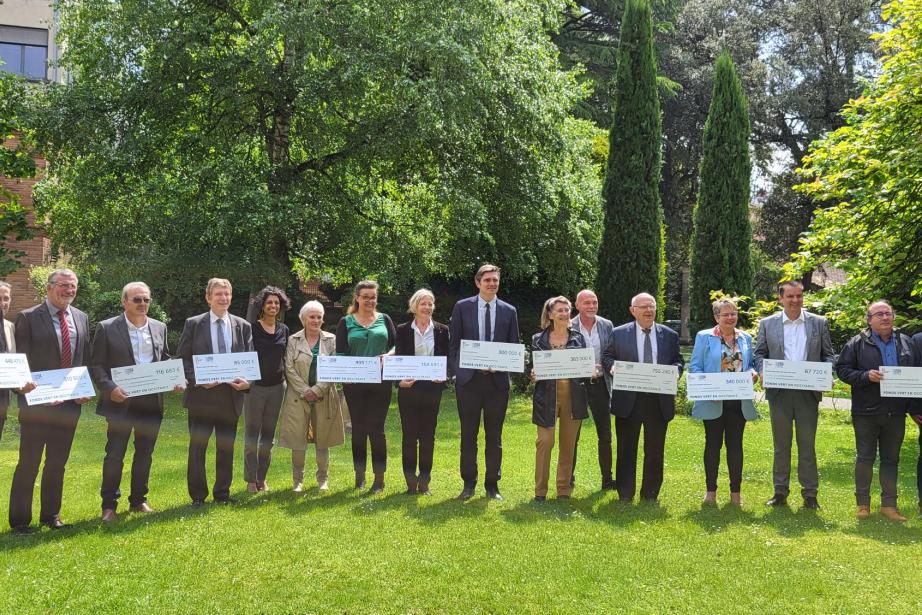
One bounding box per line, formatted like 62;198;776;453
753;280;835;510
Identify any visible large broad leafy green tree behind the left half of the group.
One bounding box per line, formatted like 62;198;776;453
34;0;600;300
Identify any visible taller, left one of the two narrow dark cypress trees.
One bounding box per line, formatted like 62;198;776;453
596;0;666;324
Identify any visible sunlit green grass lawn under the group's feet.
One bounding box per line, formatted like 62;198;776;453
0;396;922;614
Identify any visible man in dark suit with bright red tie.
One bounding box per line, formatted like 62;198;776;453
9;269;90;534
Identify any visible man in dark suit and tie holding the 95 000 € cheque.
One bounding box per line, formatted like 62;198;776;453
177;278;253;506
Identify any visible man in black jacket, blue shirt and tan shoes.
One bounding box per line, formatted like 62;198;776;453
836;300;922;521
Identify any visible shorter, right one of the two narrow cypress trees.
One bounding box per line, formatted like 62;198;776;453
689;53;752;331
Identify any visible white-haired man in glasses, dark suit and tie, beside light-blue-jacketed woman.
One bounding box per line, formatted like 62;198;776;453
602;293;685;502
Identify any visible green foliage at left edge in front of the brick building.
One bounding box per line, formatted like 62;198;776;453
0;71;35;278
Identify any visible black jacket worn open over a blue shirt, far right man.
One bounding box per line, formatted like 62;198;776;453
836;329;922;416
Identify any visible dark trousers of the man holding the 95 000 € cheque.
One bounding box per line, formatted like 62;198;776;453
186;394;240;501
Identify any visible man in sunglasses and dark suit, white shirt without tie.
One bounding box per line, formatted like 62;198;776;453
90;282;180;523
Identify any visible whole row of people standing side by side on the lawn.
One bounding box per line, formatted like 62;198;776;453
0;265;922;534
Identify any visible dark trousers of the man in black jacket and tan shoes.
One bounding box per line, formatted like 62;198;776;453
852;414;906;506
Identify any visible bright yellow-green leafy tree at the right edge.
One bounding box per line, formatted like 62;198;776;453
786;0;922;330
